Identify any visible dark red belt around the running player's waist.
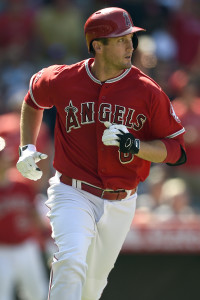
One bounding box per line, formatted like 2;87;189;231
60;174;137;201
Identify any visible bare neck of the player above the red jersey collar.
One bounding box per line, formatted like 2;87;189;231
90;60;124;82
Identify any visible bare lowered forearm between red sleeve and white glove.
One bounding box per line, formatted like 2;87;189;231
20;102;43;146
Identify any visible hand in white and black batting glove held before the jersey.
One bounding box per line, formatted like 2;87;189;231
102;122;140;154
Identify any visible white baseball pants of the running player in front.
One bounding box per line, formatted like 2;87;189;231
46;173;137;300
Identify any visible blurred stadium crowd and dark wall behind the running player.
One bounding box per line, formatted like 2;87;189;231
0;0;200;300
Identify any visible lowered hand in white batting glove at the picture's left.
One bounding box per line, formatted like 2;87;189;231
16;144;48;181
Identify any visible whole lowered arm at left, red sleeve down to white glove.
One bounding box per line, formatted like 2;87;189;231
17;68;52;181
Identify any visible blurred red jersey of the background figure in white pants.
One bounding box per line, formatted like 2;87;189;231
0;181;36;244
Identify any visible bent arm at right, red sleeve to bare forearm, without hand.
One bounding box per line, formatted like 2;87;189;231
133;88;186;166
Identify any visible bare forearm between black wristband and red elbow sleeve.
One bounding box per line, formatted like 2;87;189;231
136;140;167;163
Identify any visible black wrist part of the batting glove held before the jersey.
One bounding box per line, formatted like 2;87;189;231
117;130;140;154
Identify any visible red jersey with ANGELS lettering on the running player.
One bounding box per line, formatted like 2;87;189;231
25;59;184;189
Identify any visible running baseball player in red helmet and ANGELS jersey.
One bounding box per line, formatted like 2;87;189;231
17;7;186;300
